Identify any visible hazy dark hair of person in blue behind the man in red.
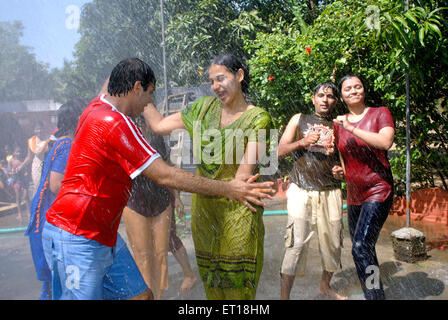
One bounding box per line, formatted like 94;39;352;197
54;98;89;138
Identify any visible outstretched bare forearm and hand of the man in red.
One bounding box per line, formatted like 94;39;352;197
143;158;275;211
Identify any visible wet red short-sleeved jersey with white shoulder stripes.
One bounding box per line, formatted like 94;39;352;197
46;95;160;247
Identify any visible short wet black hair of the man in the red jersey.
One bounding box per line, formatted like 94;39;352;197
107;58;156;96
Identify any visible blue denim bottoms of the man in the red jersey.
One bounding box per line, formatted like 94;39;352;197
42;222;148;300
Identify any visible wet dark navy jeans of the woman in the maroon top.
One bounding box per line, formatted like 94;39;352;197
347;194;393;300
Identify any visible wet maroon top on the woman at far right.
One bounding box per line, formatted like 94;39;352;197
334;107;395;205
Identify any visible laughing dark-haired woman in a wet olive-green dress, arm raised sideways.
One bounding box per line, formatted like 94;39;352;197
143;54;271;300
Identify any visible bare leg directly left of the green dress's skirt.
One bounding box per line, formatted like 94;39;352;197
150;205;173;300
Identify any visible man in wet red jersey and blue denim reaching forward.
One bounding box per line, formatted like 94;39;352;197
42;58;273;300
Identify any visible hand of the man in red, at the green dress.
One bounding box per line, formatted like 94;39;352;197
227;174;275;212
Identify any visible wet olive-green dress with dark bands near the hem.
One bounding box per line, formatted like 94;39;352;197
181;97;271;300
